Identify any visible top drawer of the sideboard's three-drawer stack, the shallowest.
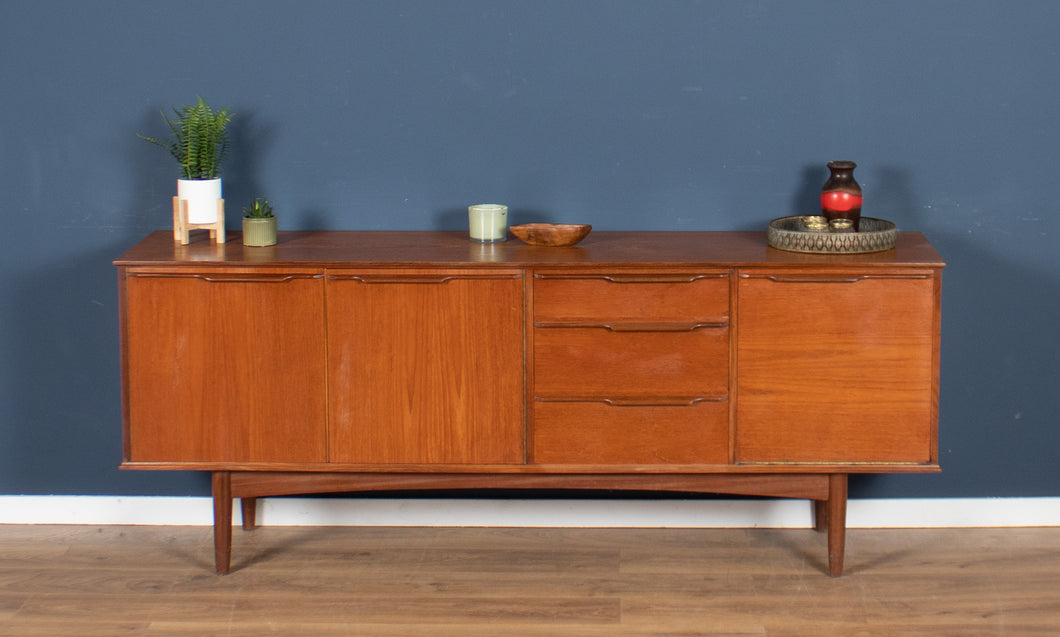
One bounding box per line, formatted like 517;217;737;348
533;270;729;322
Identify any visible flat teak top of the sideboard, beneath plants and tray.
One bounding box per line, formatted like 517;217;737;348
114;231;944;268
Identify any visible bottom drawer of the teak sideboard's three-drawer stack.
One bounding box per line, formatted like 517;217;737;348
533;400;728;464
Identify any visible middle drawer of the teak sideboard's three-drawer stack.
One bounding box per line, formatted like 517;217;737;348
533;323;729;397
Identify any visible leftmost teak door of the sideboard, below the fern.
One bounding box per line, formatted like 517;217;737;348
123;268;328;463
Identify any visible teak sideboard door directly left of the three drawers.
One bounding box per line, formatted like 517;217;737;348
326;269;525;464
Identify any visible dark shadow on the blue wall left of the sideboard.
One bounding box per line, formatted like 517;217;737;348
0;238;210;495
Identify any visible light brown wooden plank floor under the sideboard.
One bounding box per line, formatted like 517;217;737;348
0;526;1060;637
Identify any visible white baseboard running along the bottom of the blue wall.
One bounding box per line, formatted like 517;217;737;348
0;495;1060;529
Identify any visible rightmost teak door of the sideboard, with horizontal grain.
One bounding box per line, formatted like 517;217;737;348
736;270;938;464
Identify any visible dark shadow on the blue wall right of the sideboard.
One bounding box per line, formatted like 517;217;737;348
850;166;1060;498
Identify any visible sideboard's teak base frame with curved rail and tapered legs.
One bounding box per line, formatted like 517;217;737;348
212;471;847;577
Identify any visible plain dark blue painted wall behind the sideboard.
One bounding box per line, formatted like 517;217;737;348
0;0;1060;497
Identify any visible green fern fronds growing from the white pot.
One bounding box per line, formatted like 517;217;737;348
138;98;232;179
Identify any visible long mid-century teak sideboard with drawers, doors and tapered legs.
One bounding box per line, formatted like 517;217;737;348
114;231;944;576
